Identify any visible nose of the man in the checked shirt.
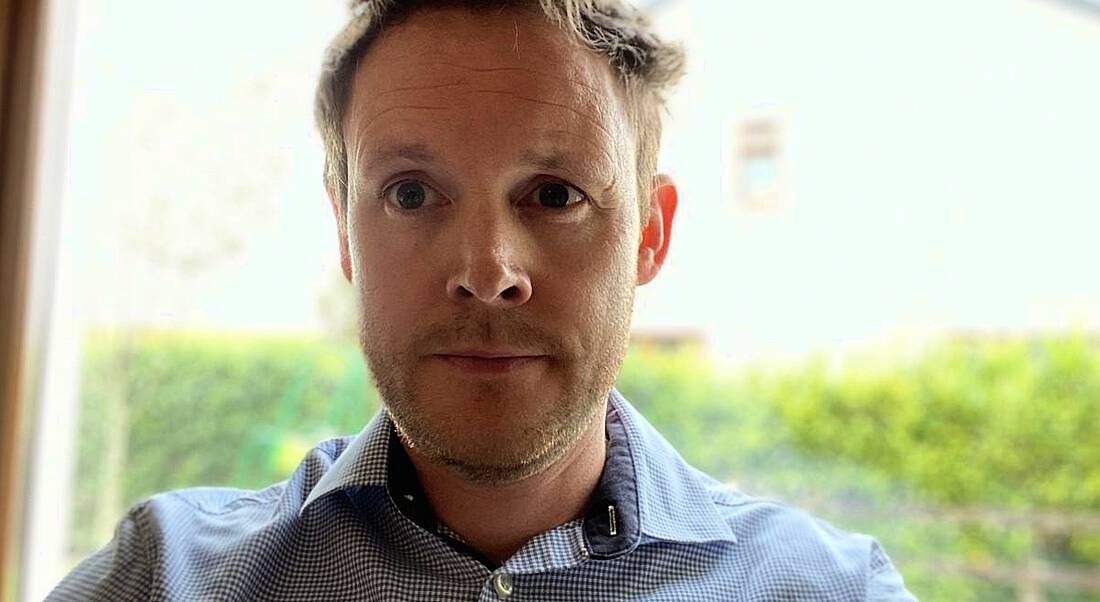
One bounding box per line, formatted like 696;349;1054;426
447;220;531;309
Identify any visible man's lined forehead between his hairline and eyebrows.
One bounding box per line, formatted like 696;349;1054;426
344;8;633;172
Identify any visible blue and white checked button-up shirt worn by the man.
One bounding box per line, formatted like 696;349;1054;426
47;391;914;602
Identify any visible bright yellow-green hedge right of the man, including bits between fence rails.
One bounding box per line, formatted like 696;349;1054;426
741;333;1100;601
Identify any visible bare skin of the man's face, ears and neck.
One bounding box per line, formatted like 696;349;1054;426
329;9;677;562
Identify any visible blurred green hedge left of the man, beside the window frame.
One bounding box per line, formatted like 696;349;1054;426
74;332;377;552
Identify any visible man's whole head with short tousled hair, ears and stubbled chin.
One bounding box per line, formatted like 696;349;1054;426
317;0;681;482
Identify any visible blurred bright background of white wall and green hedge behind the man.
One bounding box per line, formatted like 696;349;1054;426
8;0;1100;601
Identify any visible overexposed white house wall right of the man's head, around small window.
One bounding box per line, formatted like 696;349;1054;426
636;0;1100;360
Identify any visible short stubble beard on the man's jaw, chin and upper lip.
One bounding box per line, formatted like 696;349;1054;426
359;286;634;485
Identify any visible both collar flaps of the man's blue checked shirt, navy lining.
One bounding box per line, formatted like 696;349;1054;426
298;388;736;548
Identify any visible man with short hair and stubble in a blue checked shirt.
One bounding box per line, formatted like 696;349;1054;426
52;0;911;601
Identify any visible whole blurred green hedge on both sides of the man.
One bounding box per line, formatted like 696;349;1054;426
72;331;1100;600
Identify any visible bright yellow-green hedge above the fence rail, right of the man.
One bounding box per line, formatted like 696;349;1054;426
756;336;1100;510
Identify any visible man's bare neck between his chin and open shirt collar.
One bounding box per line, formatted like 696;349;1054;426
403;413;606;565
